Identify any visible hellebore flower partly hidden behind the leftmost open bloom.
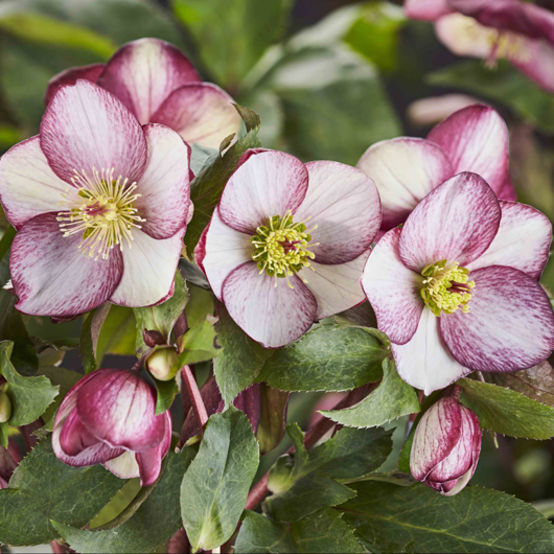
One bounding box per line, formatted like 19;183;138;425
46;38;241;148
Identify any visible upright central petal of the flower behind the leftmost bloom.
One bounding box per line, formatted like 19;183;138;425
98;38;200;125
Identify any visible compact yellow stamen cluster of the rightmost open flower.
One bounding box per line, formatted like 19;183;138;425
420;260;475;317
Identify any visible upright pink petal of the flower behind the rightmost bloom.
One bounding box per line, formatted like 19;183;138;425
427;105;508;198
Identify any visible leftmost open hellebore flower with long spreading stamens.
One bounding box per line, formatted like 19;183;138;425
0;80;192;317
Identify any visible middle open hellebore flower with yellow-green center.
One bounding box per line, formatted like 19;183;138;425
195;149;381;347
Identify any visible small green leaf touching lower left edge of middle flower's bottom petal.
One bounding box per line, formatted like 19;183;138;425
214;305;272;404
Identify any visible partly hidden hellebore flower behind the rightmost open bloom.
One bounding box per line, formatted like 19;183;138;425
358;105;516;231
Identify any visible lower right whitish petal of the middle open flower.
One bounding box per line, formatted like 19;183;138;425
298;251;369;319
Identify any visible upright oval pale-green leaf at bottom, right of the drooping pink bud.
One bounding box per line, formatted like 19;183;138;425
181;407;259;550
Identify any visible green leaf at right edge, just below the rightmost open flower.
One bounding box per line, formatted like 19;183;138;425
458;379;554;440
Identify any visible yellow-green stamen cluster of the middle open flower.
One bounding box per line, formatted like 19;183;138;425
250;210;316;278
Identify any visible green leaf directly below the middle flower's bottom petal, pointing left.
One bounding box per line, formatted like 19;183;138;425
257;323;387;391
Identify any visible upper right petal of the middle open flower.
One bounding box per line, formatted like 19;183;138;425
294;161;381;264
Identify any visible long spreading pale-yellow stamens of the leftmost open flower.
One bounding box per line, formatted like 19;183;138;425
56;168;145;260
